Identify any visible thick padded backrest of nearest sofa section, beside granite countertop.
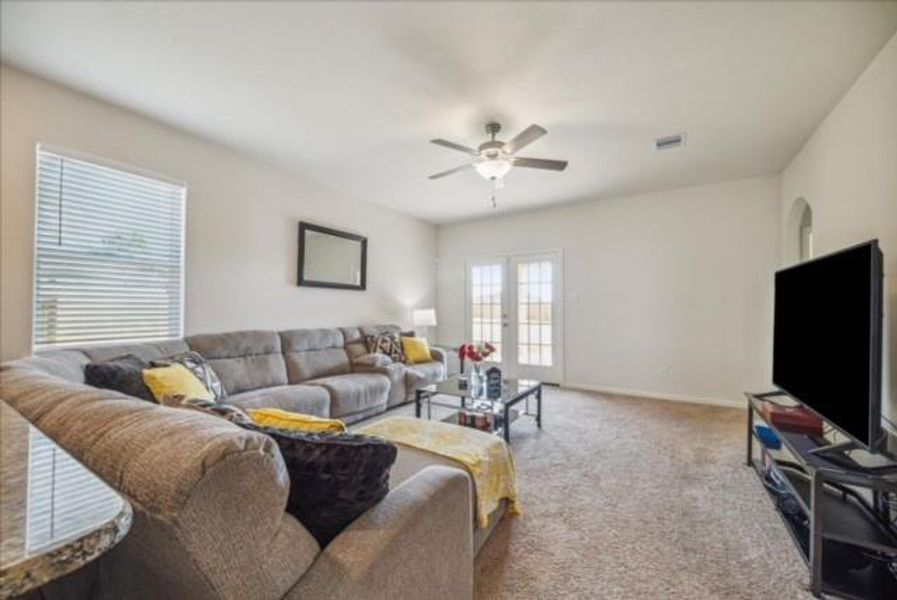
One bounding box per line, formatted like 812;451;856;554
0;368;320;600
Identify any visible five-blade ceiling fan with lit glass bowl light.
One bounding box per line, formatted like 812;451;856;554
429;123;567;184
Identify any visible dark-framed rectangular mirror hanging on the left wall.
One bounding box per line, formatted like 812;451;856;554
299;221;368;290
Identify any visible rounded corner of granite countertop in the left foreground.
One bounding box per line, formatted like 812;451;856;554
0;401;131;598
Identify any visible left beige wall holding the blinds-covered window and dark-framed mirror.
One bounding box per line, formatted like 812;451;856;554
0;67;435;359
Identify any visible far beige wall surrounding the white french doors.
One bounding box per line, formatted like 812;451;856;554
438;178;779;406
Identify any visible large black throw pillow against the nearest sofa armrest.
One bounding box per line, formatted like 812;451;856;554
253;427;396;548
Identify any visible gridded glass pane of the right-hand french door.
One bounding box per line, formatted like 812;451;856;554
517;261;554;367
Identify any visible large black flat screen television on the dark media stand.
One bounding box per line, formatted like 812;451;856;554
772;240;883;449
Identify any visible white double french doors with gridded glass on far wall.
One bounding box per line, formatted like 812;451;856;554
465;252;563;383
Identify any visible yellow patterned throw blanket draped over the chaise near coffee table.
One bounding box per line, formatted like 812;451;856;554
358;417;520;528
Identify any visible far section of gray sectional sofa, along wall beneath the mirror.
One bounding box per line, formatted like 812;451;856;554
187;325;446;423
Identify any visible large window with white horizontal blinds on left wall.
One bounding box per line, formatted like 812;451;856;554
34;149;185;349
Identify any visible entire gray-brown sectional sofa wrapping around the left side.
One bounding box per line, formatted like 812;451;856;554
0;327;501;600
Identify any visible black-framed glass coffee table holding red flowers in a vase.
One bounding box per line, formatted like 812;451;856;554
414;375;542;443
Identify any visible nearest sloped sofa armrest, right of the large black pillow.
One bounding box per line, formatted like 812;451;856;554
287;466;473;600
